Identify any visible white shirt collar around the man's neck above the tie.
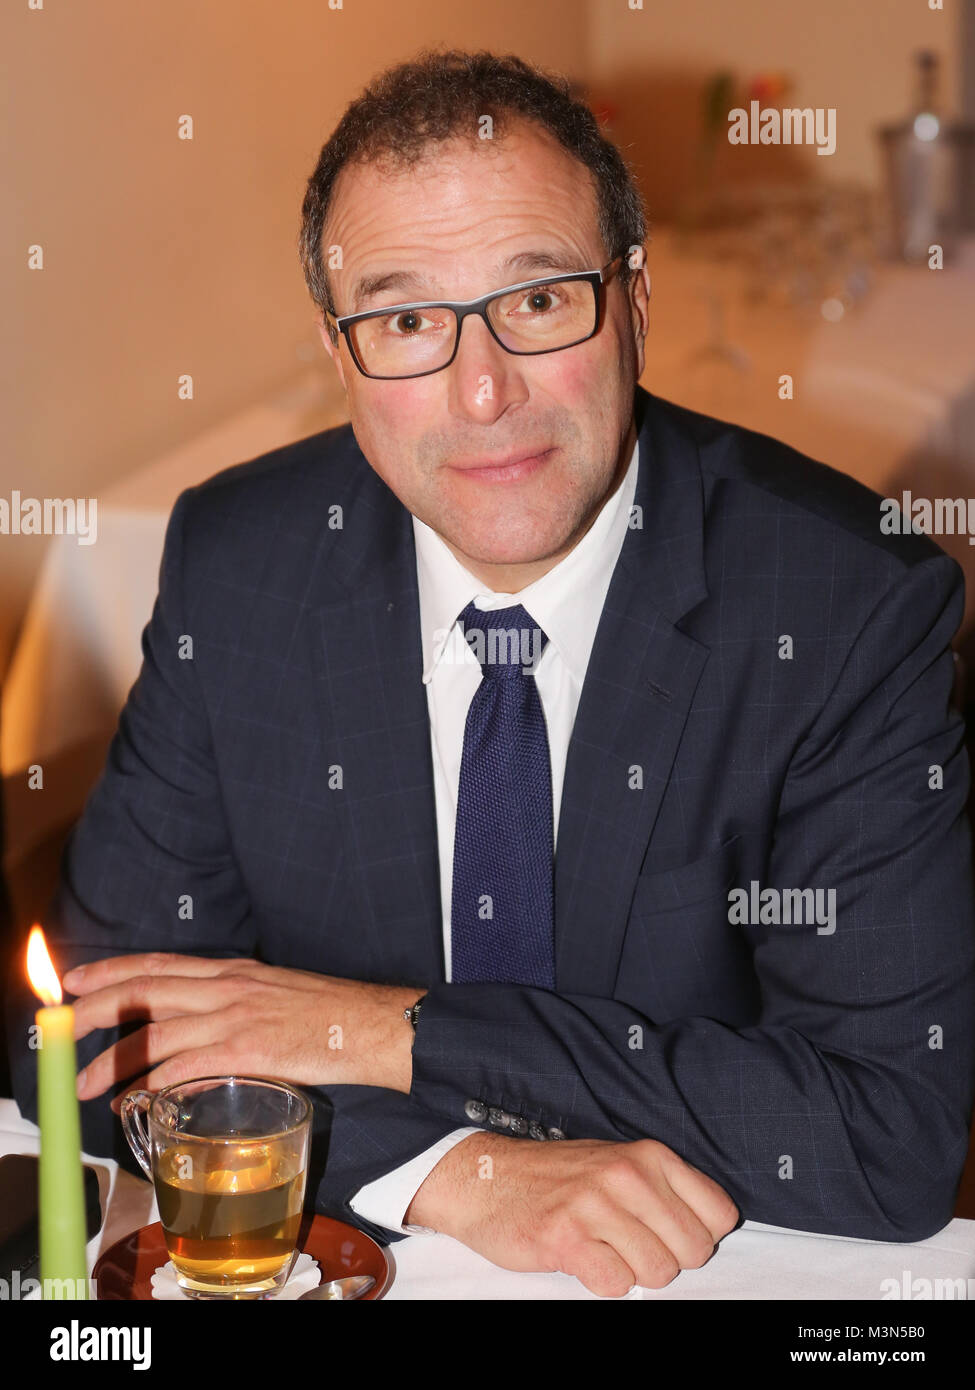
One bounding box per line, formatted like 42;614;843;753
413;441;640;687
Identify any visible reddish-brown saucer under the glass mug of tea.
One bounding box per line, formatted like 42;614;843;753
92;1212;392;1302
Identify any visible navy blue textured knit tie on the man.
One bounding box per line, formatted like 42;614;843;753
451;603;555;990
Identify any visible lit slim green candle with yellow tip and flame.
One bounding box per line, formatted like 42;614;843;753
26;926;88;1298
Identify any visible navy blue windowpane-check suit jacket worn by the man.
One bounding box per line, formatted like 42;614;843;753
8;388;975;1241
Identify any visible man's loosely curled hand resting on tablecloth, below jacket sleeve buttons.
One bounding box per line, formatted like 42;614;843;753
406;1133;739;1298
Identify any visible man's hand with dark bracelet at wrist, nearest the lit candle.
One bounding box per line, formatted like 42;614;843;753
63;952;421;1111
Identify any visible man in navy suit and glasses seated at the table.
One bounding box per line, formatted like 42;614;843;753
11;54;975;1294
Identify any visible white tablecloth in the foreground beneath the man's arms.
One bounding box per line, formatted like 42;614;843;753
0;1099;975;1301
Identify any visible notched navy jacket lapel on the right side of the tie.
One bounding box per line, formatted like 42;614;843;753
555;388;708;997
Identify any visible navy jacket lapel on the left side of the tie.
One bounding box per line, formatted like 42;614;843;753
310;438;444;986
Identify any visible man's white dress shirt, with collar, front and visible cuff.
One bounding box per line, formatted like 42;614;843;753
349;443;640;1234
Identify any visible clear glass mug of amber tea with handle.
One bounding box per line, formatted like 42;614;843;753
120;1076;312;1298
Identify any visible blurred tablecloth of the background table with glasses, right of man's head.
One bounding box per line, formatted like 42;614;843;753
641;231;975;495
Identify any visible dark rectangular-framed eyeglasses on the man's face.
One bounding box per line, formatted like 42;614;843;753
324;256;623;381
